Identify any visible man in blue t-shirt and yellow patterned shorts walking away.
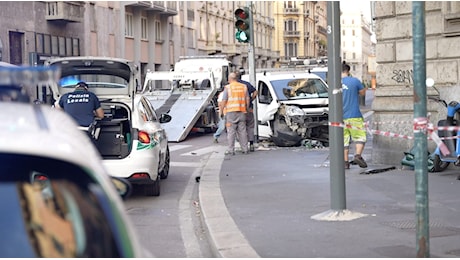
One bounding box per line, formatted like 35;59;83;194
342;62;367;169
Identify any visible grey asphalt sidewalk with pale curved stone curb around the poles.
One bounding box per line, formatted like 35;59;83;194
199;88;460;258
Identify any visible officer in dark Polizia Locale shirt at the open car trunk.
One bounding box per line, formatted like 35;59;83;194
57;82;104;127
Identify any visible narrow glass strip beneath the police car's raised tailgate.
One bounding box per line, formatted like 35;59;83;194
59;74;128;88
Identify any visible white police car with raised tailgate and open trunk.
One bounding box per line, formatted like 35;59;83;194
46;57;171;196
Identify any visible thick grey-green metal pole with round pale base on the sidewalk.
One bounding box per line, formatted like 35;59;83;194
327;1;346;210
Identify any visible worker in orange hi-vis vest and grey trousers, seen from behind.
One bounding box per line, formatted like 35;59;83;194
222;73;249;155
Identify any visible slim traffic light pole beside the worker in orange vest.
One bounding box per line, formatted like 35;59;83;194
246;1;259;143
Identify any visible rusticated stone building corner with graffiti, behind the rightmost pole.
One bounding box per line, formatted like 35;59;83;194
372;1;460;165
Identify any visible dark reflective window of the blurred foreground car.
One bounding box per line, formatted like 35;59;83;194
0;153;121;258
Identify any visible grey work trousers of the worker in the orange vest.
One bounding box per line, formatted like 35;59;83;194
225;112;248;152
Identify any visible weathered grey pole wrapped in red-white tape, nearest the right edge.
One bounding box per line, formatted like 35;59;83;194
412;1;430;257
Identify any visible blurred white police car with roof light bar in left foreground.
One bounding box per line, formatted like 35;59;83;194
0;67;149;258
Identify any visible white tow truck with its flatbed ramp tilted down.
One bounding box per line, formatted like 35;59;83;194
143;71;219;142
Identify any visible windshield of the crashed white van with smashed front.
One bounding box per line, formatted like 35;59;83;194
270;78;328;101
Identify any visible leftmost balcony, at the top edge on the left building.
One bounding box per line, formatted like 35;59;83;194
45;2;84;23
